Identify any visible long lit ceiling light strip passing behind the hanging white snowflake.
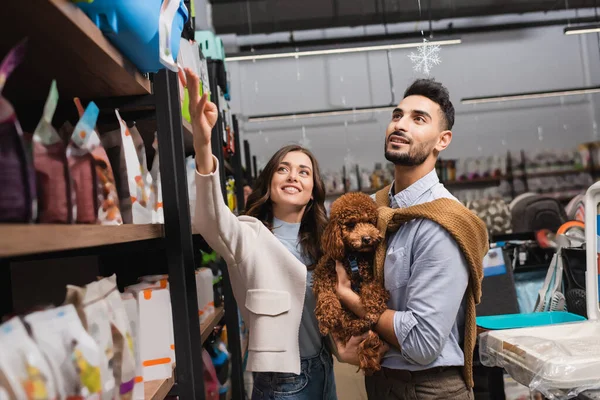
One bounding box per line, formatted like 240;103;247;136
225;39;461;61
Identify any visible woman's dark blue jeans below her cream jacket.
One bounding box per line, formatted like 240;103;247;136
252;347;337;400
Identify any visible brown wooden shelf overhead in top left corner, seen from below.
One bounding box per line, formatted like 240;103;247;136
0;0;152;104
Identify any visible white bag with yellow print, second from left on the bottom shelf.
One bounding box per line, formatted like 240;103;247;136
25;304;102;400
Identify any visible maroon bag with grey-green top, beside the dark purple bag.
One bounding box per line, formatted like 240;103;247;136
33;81;75;224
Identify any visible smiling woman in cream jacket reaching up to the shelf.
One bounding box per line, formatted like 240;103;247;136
186;65;336;400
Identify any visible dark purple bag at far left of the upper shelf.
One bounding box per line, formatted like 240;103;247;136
0;41;37;222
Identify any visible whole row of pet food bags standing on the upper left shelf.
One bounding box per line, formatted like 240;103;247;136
0;43;163;225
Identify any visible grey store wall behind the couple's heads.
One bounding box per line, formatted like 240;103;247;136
228;26;600;170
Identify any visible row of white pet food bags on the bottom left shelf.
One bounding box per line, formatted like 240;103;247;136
0;276;138;400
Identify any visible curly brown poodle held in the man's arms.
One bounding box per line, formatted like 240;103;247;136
313;193;389;375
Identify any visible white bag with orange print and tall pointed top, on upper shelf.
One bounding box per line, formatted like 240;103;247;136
115;110;152;224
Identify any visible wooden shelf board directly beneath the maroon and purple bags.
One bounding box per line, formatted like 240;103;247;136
0;224;163;258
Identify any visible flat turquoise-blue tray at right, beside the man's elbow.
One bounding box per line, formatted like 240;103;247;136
477;311;585;330
